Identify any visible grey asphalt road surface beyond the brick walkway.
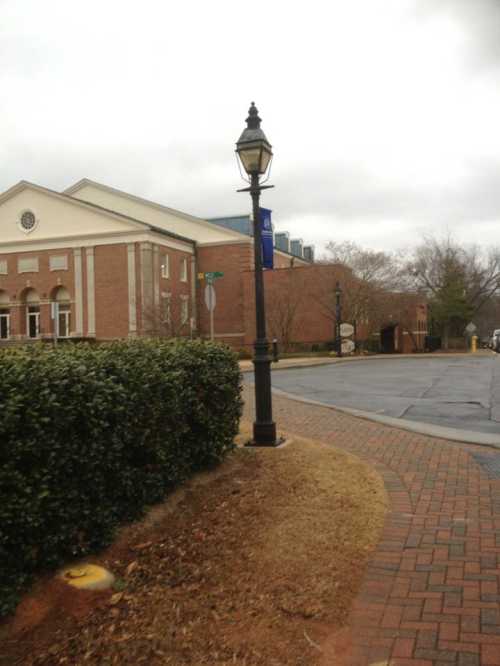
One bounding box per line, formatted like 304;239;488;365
260;354;500;434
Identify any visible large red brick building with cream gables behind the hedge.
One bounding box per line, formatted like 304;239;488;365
0;179;423;351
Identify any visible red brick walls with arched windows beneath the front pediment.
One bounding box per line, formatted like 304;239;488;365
0;243;193;342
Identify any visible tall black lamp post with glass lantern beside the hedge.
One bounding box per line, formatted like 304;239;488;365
236;102;278;446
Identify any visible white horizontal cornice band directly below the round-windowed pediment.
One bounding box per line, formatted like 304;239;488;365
0;231;193;254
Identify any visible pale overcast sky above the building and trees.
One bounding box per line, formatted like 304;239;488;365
0;0;500;249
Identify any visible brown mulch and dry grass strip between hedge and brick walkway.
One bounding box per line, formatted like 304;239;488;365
0;424;387;666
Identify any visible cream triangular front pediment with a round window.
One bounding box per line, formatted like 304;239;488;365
0;182;145;245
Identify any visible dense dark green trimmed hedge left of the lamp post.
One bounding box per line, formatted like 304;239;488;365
0;340;242;615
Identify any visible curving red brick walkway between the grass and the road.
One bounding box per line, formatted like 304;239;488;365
245;388;500;666
